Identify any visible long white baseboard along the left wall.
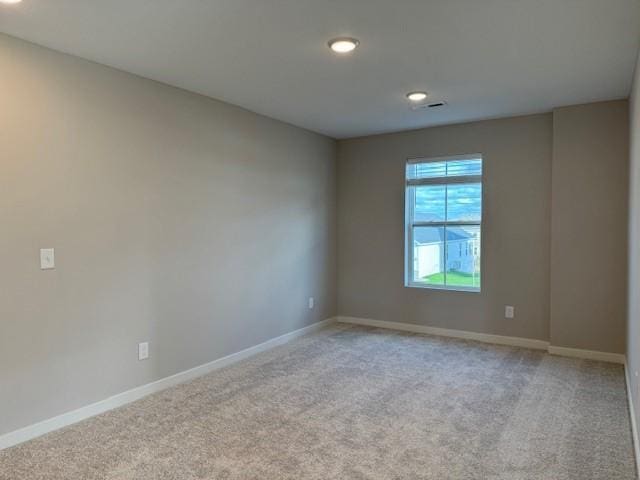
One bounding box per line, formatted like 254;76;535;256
0;318;334;450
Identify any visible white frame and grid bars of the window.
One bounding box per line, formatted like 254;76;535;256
404;153;484;293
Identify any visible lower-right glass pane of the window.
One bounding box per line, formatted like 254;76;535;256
446;226;480;289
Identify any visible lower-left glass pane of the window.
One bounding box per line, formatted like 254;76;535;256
413;227;445;286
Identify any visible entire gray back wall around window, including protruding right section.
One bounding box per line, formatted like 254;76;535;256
338;100;628;353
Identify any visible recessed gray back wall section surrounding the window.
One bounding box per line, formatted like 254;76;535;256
338;114;552;340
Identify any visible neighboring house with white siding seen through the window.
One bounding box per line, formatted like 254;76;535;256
413;227;480;278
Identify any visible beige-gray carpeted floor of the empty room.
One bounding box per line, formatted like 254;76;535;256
0;325;635;480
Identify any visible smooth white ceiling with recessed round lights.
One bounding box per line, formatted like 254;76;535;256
0;0;640;138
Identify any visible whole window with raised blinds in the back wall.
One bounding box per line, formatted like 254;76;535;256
405;155;482;291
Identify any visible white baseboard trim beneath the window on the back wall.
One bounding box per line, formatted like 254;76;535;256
336;317;549;350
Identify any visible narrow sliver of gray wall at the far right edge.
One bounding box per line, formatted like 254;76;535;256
627;49;640;436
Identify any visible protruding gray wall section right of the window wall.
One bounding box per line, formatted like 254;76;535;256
551;100;629;353
